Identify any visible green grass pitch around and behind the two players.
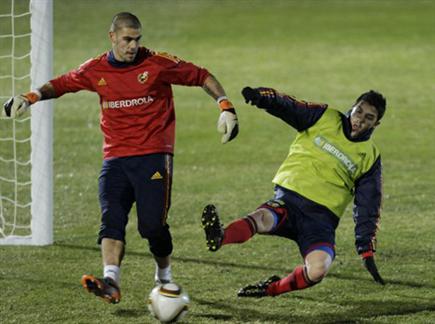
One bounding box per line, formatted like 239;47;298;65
0;0;435;323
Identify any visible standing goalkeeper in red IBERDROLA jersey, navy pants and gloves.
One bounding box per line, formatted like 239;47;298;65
4;12;238;303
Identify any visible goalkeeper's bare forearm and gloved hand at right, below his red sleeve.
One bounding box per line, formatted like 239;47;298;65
202;74;239;144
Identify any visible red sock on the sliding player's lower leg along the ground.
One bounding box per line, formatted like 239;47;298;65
267;266;316;296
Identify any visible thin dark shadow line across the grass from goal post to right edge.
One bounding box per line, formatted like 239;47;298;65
54;242;435;289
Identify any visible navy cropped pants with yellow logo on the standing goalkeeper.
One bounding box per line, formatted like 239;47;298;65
98;153;172;243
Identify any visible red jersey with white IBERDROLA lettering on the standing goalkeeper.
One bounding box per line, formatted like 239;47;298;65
50;47;209;159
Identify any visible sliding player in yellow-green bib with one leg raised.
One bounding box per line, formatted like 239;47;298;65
202;87;386;297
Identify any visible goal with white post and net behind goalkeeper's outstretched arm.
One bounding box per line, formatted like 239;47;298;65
0;0;53;245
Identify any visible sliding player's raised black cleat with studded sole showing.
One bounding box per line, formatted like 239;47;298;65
201;205;224;252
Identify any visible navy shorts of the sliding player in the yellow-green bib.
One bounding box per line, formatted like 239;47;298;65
260;186;339;257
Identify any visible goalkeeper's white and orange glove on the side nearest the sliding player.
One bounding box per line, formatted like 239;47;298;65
217;97;239;144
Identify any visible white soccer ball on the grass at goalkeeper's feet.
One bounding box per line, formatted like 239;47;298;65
148;282;190;323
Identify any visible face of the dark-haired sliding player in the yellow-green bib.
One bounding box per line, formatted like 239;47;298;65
350;101;379;137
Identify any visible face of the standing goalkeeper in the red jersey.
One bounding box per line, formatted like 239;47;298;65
109;27;142;63
